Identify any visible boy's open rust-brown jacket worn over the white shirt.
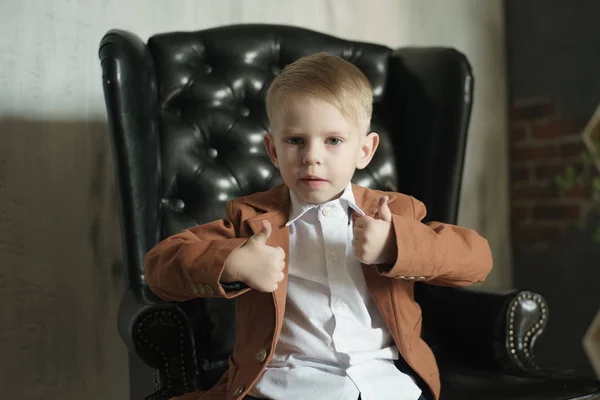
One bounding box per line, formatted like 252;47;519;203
145;185;492;400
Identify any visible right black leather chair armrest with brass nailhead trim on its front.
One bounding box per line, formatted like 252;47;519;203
415;284;549;375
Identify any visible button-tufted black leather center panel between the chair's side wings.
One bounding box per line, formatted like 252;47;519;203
148;25;397;241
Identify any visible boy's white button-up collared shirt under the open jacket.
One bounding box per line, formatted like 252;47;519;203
250;184;421;400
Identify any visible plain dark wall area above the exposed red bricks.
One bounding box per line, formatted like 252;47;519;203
505;0;600;118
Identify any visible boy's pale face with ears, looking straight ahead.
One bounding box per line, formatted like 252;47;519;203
265;96;379;204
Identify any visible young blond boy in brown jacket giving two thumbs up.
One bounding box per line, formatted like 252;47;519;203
145;53;492;400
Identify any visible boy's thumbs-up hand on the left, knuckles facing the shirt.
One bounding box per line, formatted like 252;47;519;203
222;221;285;292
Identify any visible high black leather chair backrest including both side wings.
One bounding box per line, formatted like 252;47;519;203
100;25;473;390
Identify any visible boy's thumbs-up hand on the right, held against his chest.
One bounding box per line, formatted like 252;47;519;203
352;196;397;264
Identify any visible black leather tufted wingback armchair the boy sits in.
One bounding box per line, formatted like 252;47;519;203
100;25;600;400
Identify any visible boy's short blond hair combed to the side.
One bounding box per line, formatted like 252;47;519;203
266;53;373;133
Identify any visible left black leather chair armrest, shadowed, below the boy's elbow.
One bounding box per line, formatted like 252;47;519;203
118;286;235;400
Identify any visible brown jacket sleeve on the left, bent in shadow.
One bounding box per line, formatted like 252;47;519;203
144;202;249;301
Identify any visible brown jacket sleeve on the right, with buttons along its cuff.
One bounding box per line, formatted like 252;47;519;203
379;197;492;286
